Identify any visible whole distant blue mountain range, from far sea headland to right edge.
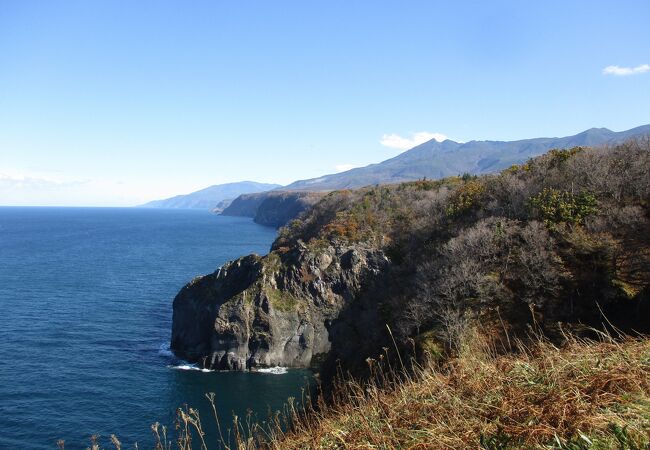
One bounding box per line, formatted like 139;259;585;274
142;125;650;217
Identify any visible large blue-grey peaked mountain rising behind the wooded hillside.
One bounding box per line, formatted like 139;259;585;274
283;125;650;191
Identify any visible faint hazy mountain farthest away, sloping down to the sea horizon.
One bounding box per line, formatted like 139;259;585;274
141;181;280;212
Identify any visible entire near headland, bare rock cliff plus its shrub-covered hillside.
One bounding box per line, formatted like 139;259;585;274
172;141;650;372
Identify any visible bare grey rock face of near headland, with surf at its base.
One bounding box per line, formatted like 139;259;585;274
171;245;388;370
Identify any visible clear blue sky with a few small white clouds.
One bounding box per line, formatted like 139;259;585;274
0;0;650;206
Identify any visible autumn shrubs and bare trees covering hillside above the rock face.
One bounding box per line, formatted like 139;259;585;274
274;140;650;350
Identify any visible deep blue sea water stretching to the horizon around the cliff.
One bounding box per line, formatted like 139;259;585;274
0;207;309;449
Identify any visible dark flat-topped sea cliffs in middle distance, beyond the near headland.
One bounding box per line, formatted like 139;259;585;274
221;191;325;228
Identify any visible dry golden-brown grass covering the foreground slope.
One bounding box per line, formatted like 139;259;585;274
60;335;650;450
